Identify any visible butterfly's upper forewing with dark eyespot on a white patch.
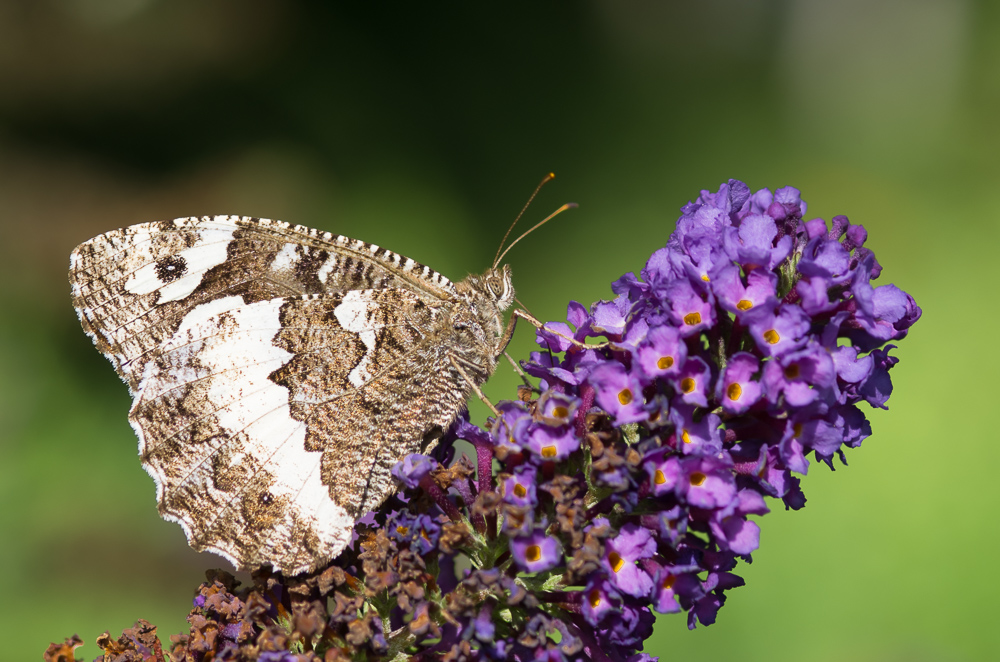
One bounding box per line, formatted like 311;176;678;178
70;216;454;391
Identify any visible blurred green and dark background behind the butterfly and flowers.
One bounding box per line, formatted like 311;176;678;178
0;0;1000;662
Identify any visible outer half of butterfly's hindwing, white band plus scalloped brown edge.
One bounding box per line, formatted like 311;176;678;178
129;297;354;572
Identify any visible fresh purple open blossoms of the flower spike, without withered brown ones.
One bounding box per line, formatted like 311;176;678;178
516;180;921;644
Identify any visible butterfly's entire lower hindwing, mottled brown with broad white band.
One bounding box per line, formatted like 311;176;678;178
130;289;467;571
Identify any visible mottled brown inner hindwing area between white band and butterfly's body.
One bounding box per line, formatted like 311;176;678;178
271;289;478;518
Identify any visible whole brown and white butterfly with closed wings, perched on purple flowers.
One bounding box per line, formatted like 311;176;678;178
69;216;524;574
